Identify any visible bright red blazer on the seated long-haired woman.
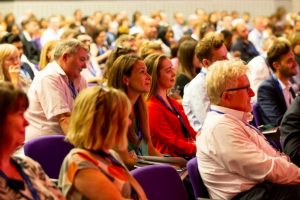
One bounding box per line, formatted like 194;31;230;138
147;96;197;156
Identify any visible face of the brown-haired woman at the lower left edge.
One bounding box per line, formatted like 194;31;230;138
3;108;29;149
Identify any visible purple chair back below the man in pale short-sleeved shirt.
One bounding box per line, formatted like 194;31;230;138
24;135;74;179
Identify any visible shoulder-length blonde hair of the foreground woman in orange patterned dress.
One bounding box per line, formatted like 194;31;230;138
66;86;131;150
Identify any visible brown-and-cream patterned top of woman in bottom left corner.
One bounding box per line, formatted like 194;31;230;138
0;156;65;200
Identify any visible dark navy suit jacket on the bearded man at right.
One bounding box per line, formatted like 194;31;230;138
257;75;287;126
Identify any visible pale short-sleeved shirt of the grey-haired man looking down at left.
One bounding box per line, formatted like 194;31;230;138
25;61;87;141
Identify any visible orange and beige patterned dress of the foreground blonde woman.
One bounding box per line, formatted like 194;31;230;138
58;148;138;200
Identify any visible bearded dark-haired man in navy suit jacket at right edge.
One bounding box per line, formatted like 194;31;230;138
257;38;297;126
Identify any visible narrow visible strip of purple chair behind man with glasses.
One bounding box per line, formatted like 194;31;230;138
187;157;209;199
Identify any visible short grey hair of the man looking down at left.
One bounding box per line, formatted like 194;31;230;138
54;39;89;60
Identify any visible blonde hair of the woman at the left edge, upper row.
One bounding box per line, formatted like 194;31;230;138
0;44;18;81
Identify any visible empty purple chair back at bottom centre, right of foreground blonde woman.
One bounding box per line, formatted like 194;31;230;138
130;165;188;200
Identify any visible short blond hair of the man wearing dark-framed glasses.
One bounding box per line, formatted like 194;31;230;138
206;59;248;105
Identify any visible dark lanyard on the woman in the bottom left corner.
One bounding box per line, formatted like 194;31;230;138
0;160;40;200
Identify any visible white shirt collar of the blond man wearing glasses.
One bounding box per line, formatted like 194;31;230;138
211;105;252;123
